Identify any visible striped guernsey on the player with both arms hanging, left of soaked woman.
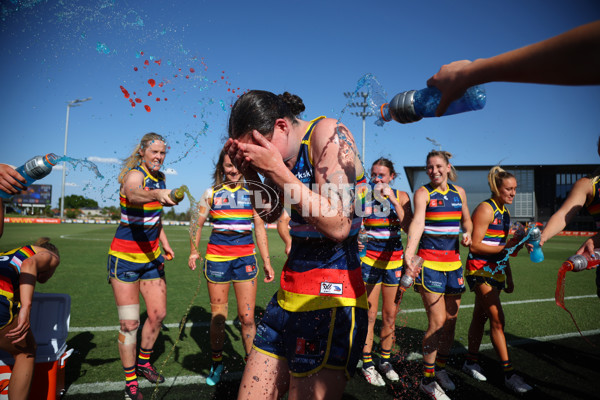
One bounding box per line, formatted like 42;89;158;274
206;186;256;261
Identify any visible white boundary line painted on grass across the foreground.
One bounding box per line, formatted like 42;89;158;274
66;329;600;396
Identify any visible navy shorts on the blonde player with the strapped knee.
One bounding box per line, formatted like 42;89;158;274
106;255;165;283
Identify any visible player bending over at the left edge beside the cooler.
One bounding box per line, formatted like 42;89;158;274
0;237;60;400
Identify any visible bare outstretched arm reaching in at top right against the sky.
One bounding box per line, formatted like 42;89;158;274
427;21;600;117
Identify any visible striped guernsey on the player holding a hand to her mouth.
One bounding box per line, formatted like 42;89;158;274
361;189;404;269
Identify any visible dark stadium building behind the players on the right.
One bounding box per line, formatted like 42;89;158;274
404;164;598;231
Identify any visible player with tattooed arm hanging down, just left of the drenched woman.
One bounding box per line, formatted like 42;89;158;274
188;151;275;386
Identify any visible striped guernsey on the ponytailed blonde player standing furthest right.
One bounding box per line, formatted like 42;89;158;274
466;199;510;276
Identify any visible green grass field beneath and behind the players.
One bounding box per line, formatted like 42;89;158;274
0;224;600;400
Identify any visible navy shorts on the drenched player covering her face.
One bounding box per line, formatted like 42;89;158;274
253;294;367;378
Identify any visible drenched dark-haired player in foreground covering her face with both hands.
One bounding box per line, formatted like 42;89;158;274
225;90;367;399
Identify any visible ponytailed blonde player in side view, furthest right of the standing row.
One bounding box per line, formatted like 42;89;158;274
463;166;532;393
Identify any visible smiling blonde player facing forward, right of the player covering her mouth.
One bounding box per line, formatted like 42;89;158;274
404;150;473;400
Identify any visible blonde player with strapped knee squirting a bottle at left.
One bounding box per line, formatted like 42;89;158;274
107;132;176;400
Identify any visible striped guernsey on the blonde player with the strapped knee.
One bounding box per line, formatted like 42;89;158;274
108;165;166;263
